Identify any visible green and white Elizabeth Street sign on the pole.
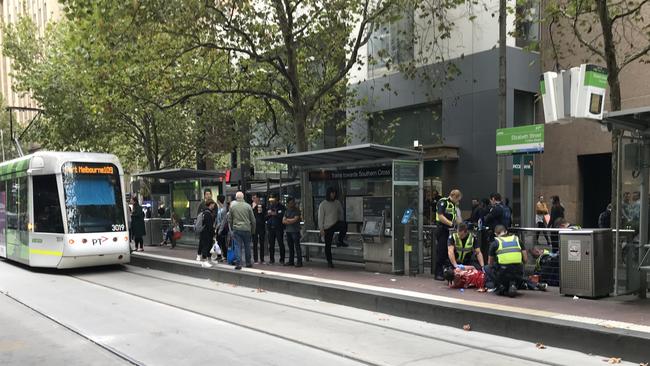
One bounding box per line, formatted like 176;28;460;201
497;124;544;155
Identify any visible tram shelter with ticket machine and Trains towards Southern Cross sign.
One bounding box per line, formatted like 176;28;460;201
260;144;424;274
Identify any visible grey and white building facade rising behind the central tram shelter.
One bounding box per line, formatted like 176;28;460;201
348;1;540;220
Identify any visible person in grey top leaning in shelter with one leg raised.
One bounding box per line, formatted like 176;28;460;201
318;187;348;268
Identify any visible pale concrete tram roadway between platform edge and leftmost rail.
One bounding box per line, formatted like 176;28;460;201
0;262;636;365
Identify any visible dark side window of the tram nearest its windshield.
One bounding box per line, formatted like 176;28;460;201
33;174;63;233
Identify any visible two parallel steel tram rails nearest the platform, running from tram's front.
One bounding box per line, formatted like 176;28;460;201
69;267;565;366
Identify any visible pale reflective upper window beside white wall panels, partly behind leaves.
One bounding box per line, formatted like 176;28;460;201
367;9;415;74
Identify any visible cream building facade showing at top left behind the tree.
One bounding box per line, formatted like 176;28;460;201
0;0;61;121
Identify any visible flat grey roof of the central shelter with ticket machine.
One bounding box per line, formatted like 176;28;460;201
259;144;420;168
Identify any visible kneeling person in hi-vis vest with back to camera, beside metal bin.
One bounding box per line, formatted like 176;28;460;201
485;225;528;297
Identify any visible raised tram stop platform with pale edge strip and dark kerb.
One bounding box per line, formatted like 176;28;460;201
131;246;650;363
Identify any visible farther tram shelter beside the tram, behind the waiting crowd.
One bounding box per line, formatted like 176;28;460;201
132;169;225;246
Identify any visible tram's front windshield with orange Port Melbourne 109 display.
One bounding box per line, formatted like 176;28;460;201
63;163;126;234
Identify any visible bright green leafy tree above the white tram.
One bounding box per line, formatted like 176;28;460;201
3;18;204;170
